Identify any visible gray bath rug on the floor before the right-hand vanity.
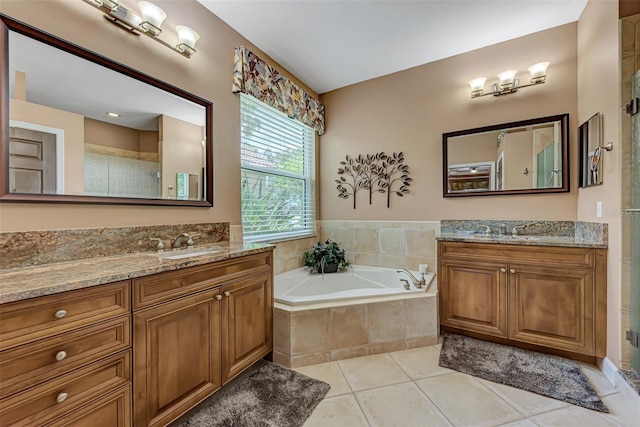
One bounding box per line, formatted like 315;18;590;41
438;334;609;412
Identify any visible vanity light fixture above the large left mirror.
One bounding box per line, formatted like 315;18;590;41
84;0;200;58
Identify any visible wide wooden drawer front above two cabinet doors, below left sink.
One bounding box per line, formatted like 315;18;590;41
133;251;272;310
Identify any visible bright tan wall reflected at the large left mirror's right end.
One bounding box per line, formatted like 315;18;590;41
160;115;202;198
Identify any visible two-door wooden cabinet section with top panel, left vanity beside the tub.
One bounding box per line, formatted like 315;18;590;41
133;252;273;426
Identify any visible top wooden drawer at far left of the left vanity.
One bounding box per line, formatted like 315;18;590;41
0;281;131;349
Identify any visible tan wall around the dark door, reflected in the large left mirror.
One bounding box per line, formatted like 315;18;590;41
9;99;84;194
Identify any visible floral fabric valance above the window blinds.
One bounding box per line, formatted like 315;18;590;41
232;46;324;135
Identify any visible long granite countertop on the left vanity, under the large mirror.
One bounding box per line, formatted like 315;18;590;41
0;242;274;304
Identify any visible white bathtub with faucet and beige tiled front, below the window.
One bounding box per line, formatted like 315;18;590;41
273;266;439;368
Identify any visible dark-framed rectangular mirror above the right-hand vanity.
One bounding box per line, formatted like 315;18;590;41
442;114;569;197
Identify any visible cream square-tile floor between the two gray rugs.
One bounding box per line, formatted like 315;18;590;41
295;345;640;427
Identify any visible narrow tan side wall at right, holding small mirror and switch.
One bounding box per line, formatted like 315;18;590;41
573;0;622;366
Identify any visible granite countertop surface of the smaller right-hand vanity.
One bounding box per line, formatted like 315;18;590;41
436;233;608;249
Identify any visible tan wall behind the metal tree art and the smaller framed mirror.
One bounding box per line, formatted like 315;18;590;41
319;23;577;221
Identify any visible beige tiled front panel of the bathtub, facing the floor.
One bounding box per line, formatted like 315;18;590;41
273;292;439;367
